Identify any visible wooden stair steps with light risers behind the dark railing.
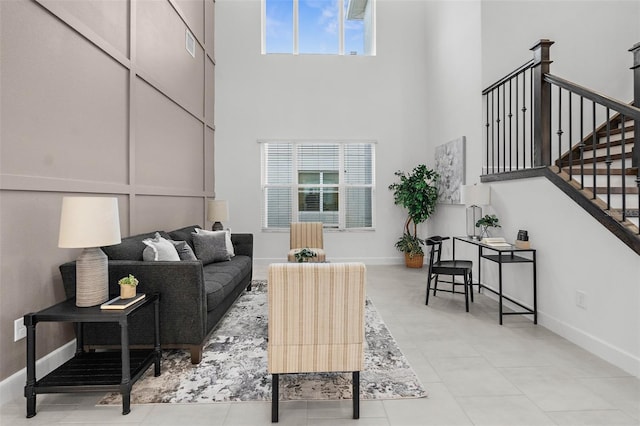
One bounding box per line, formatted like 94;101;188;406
554;114;640;231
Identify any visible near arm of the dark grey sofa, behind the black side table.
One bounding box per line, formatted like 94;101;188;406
60;260;207;345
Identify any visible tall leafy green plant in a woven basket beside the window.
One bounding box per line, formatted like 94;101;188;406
389;164;440;268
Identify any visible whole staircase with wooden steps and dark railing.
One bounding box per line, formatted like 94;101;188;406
481;39;640;255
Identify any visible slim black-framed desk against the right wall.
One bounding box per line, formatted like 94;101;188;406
453;237;538;325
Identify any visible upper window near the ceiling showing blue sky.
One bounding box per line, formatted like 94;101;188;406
262;0;375;55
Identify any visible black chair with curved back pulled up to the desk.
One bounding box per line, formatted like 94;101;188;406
425;235;473;312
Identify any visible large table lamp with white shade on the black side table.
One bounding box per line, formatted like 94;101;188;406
58;197;121;307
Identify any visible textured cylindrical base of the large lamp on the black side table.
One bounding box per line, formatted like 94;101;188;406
76;247;109;308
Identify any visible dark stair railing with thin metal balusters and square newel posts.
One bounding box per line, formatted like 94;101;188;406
482;39;640;233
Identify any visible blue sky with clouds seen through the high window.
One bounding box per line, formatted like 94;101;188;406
264;0;364;55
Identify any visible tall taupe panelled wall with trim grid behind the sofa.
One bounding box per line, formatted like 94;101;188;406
0;0;215;380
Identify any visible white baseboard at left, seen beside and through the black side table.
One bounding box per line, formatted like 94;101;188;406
0;339;76;405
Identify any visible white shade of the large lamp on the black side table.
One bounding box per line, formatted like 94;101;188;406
58;197;121;248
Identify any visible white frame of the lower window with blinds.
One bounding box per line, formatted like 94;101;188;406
258;139;377;232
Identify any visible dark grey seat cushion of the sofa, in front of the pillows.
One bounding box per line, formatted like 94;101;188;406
203;255;251;311
